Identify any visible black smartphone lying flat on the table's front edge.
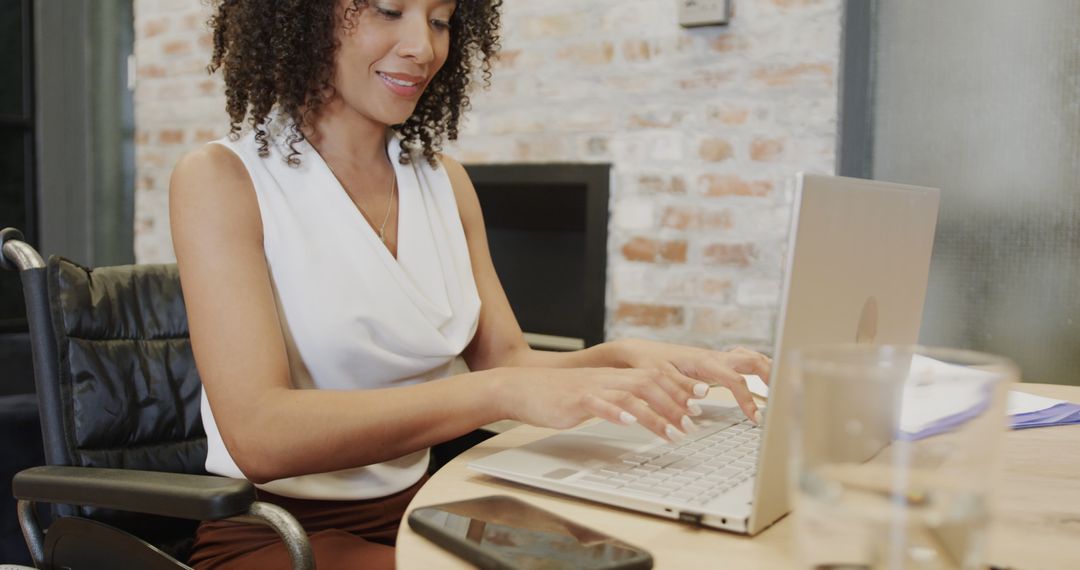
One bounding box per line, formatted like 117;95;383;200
408;496;652;570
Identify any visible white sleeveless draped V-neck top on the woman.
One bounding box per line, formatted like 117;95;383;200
202;123;480;500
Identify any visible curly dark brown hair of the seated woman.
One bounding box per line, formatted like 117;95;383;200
207;0;502;166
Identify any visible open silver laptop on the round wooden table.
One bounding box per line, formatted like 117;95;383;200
469;174;939;534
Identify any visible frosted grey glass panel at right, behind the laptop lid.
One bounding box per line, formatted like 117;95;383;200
873;0;1080;384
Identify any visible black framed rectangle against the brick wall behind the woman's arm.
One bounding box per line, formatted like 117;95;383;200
465;164;611;350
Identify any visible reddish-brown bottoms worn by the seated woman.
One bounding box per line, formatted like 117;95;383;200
190;476;428;570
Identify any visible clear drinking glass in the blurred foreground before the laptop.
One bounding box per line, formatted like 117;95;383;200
792;345;1018;570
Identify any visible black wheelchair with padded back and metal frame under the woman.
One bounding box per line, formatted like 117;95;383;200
0;228;314;570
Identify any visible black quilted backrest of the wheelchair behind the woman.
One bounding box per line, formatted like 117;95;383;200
23;256;206;547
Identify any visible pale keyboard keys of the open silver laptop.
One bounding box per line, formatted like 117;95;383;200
579;420;761;505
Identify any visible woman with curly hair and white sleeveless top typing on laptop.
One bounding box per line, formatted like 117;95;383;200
170;0;769;568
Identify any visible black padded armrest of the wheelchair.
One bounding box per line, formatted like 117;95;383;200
12;465;255;520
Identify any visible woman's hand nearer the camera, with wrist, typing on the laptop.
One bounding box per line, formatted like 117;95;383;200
491;368;708;440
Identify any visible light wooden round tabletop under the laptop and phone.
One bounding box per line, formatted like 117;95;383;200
397;384;1080;570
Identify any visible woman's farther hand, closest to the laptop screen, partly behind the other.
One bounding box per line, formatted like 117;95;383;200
613;339;772;423
